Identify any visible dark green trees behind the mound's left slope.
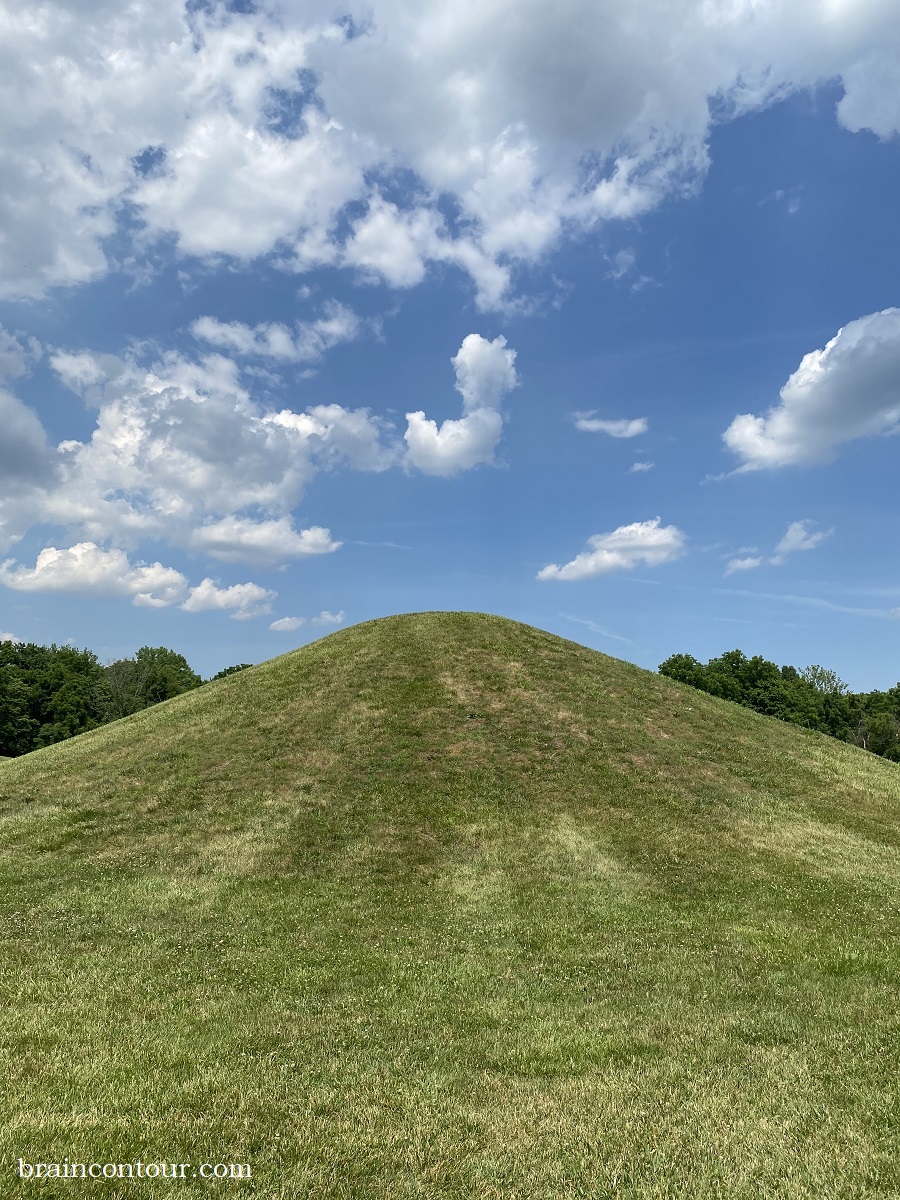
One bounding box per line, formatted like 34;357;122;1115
0;642;250;758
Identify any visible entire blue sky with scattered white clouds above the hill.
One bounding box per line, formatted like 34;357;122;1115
0;0;900;690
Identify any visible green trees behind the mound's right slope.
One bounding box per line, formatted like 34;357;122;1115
659;650;900;762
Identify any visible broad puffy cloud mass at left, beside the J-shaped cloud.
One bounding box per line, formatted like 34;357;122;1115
0;350;402;563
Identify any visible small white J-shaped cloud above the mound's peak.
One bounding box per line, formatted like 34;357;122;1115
404;334;517;475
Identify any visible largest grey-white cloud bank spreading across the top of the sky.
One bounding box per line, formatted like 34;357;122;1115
7;0;900;304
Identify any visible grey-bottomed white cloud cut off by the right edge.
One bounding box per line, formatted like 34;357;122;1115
722;308;900;472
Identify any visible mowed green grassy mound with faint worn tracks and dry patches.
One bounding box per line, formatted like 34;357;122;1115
0;613;900;1200
